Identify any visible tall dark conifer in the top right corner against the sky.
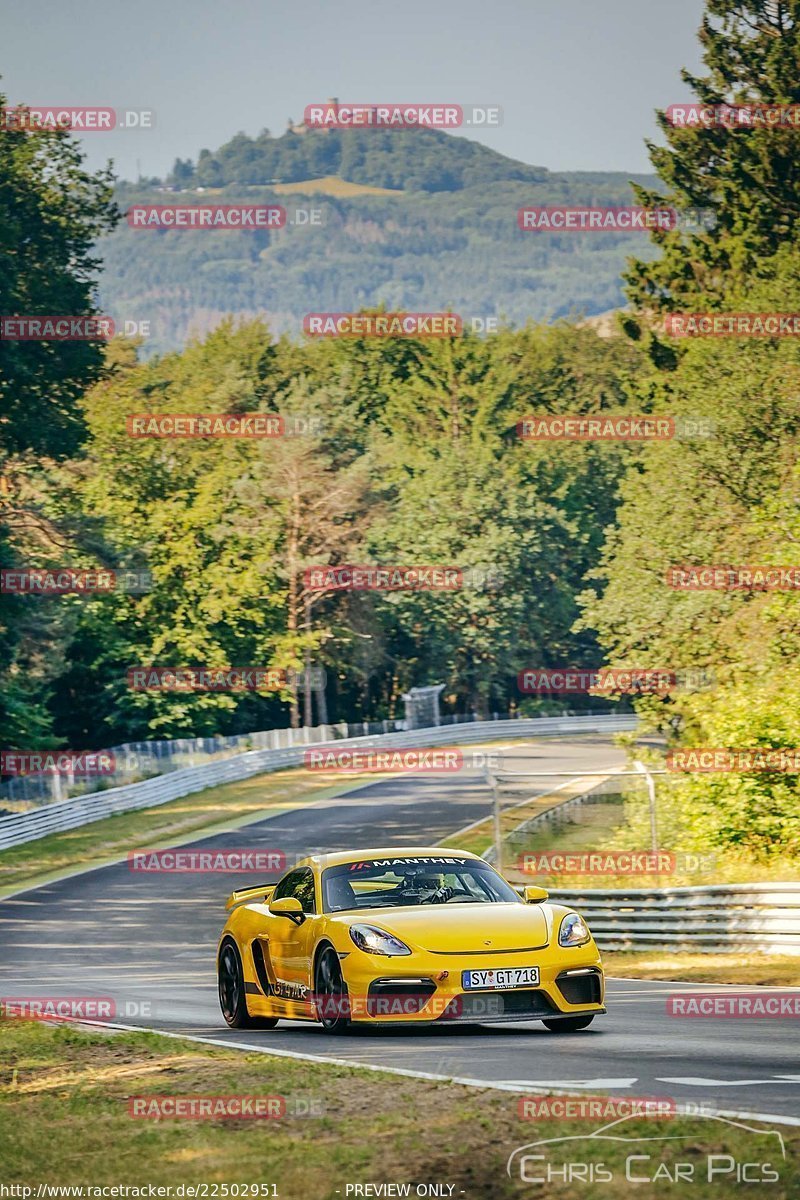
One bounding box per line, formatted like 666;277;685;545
625;0;800;326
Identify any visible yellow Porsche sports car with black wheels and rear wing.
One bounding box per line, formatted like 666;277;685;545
217;847;606;1033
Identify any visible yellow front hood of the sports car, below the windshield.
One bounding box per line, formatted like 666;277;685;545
335;904;549;954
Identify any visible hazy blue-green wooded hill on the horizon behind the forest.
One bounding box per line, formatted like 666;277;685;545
100;130;655;353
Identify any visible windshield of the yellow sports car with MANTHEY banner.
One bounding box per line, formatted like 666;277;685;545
323;856;522;912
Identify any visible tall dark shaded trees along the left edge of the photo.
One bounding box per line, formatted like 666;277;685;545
0;95;116;745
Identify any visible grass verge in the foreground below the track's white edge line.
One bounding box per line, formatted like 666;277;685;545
0;1021;800;1200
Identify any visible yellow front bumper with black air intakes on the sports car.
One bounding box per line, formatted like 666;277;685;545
342;946;606;1024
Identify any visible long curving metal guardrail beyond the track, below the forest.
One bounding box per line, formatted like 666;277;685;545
0;714;636;850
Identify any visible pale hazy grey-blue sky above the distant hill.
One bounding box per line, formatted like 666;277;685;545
0;0;703;178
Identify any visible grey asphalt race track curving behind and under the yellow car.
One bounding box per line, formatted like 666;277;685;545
0;737;800;1118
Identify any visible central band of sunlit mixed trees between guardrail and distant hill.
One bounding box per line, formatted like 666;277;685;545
34;323;638;744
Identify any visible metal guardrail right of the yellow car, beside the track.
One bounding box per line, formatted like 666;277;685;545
551;882;800;955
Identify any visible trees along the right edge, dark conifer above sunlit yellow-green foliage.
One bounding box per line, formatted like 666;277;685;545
582;0;800;860
